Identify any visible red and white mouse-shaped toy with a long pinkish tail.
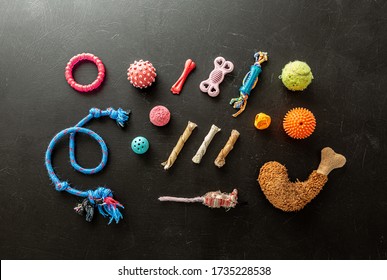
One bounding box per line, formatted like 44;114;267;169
159;189;238;209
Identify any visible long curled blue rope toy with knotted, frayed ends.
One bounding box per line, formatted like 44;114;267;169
45;108;130;224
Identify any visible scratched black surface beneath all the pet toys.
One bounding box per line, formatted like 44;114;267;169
0;0;387;259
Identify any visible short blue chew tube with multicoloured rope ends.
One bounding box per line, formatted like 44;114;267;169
230;51;268;118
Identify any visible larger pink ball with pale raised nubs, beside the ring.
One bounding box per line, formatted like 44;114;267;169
128;59;157;88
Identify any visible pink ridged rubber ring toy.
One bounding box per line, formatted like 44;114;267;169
65;53;105;92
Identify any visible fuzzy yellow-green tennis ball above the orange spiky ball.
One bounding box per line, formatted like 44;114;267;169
279;60;313;91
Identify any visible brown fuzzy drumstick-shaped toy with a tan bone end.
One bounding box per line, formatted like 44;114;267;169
258;147;346;212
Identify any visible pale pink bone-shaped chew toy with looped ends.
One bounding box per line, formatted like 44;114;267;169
200;56;234;97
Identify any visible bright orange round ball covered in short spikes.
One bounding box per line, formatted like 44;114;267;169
283;108;316;139
